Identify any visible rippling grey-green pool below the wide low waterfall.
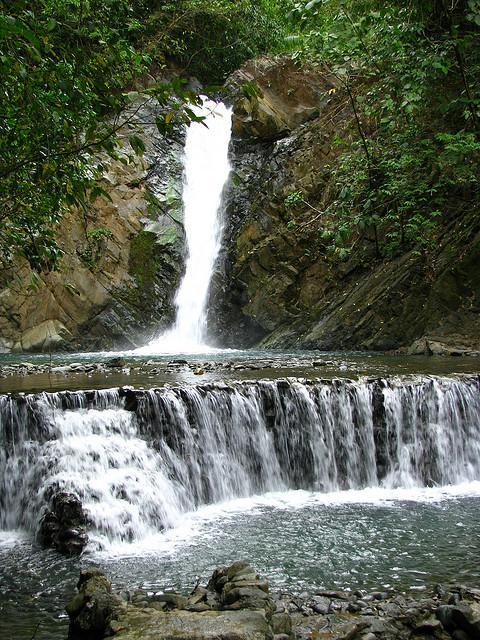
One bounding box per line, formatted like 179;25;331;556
0;482;480;640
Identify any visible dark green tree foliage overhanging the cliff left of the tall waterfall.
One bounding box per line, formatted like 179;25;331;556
0;0;204;271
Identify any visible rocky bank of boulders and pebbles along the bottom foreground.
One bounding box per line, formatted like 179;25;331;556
67;561;480;640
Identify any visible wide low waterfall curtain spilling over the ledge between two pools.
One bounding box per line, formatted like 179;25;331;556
0;376;480;540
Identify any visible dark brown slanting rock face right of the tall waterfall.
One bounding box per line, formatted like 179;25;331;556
211;58;480;355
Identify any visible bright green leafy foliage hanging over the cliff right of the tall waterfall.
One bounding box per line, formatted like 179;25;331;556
286;0;480;259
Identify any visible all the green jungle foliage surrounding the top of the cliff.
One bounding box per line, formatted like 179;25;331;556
0;0;480;271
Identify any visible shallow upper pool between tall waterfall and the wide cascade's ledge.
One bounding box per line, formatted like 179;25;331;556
0;350;480;393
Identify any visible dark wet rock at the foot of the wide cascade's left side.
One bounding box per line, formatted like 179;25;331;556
39;492;88;555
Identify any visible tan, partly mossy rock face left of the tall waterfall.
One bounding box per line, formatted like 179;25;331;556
0;97;184;352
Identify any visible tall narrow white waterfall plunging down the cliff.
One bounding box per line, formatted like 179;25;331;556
137;100;231;354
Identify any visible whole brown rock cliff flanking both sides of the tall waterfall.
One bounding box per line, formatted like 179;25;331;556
0;56;480;354
